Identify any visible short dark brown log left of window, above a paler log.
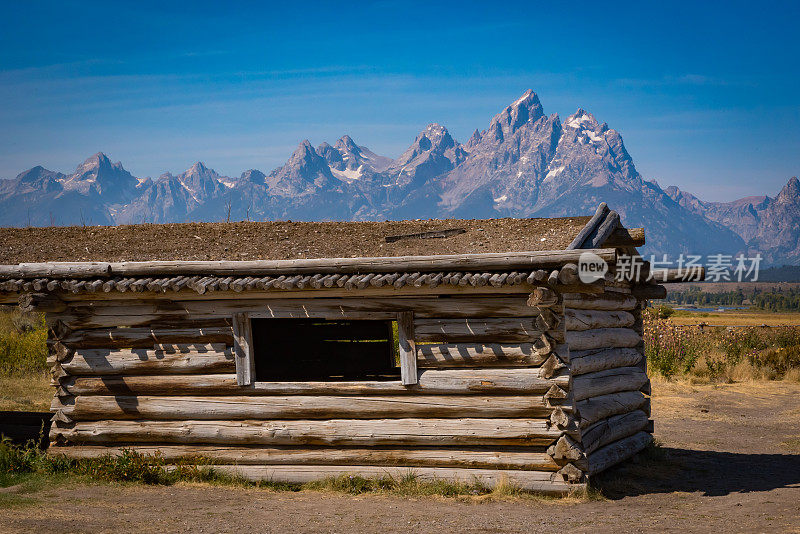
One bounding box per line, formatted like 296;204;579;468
60;326;233;349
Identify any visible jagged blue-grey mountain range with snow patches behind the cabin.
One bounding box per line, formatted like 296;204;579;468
0;91;800;264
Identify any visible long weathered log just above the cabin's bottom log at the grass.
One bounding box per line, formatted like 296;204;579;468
48;445;559;471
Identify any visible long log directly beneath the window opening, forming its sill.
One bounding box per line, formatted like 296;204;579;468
61;368;569;395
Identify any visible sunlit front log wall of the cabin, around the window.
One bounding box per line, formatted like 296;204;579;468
42;288;580;492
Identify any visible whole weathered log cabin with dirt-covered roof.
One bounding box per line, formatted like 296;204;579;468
0;204;680;494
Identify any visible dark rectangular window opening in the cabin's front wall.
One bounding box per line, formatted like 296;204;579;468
252;319;400;382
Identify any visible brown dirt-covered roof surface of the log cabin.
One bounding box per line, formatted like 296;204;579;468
0;217;589;265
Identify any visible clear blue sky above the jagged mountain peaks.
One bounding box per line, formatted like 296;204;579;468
0;1;800;200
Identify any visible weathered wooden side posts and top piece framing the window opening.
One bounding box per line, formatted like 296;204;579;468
233;307;418;386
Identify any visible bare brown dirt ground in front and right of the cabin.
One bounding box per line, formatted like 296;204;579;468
0;382;800;534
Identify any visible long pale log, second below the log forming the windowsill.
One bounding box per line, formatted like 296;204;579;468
57;418;561;446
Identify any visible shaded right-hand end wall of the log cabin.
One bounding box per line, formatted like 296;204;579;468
554;276;652;475
